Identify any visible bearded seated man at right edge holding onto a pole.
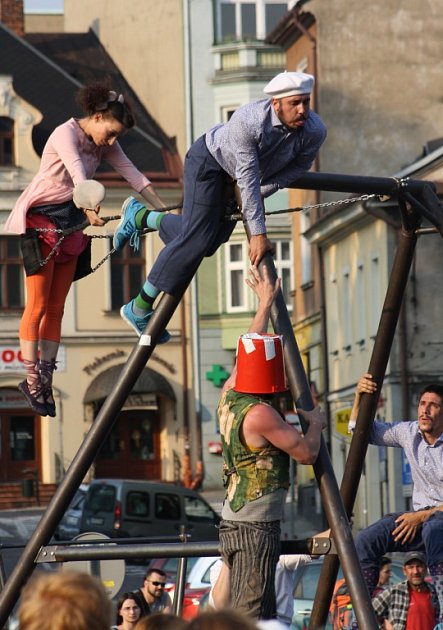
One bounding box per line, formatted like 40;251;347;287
350;374;443;624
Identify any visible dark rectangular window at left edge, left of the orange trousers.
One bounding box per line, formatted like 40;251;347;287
0;236;25;310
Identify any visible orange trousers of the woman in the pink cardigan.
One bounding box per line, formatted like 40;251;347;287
19;243;77;342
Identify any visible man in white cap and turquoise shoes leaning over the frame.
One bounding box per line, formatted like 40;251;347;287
114;72;326;341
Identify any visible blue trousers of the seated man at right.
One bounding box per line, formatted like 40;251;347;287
355;512;443;593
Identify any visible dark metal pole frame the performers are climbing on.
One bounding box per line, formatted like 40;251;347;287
0;173;443;630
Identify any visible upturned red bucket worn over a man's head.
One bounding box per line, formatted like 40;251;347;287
233;333;287;394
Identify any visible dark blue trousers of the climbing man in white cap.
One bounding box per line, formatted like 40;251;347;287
148;136;235;295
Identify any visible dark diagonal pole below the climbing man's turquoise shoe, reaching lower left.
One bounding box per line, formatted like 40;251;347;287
0;290;186;628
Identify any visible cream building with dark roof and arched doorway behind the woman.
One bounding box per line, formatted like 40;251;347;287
0;8;186;494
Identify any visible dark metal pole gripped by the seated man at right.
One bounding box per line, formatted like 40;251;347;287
311;206;417;628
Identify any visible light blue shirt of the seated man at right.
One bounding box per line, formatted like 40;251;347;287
369;421;443;510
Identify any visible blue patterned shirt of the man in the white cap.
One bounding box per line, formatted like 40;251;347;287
205;98;326;235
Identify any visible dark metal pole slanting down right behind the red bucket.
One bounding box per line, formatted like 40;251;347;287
260;254;379;630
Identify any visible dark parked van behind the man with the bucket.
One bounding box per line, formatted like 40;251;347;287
80;479;220;541
